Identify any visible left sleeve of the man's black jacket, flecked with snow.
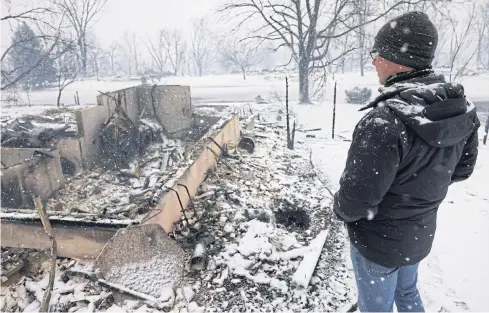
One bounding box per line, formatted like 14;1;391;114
333;108;405;223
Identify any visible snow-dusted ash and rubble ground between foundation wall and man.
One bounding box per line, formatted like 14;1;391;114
174;112;352;312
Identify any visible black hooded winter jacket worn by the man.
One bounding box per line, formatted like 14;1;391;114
334;71;480;268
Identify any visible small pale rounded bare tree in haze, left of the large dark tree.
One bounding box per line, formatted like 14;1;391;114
220;40;263;79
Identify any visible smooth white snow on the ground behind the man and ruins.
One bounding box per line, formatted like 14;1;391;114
2;72;489;311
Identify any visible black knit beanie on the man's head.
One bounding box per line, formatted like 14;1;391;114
373;11;438;69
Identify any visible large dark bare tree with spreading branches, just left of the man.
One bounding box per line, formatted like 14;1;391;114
220;0;424;103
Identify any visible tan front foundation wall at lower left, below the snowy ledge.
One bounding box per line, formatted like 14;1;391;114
1;214;127;260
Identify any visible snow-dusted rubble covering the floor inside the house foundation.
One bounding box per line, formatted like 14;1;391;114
2;140;184;221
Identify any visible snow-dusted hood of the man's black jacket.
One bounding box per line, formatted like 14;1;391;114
370;73;479;147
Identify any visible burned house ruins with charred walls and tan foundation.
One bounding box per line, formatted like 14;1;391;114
1;86;248;258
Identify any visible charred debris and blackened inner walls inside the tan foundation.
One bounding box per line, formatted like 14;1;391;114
1;86;215;212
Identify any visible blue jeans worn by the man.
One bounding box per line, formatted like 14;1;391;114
351;244;424;312
